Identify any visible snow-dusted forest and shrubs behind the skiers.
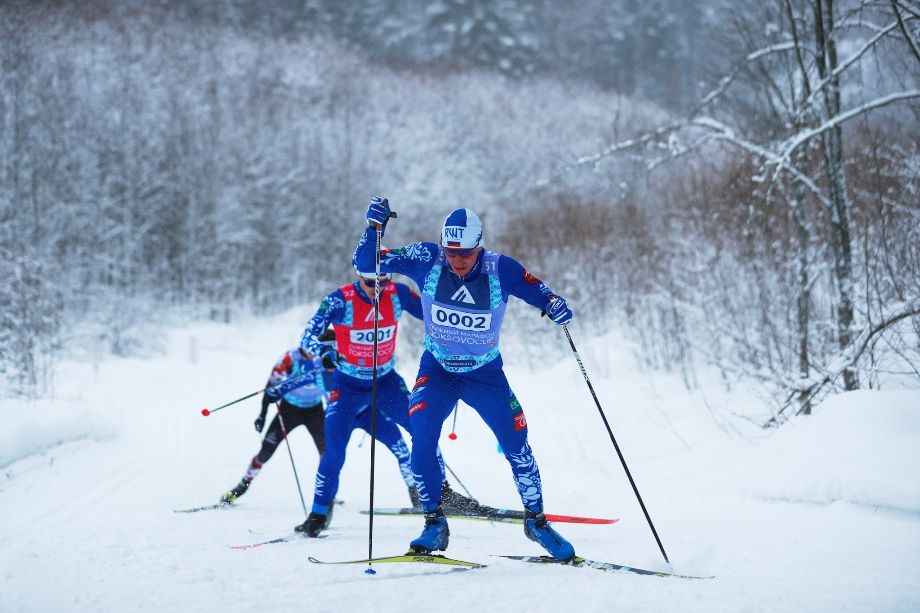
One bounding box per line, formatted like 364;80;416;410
0;0;920;420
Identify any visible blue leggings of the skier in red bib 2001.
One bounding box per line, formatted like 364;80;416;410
313;370;414;506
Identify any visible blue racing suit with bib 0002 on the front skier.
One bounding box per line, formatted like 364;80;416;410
353;228;555;512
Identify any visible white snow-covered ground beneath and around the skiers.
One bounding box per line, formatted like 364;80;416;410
0;306;920;613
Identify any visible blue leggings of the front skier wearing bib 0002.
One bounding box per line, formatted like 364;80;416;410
406;351;543;512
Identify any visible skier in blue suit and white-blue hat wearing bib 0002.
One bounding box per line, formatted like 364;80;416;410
354;197;575;560
